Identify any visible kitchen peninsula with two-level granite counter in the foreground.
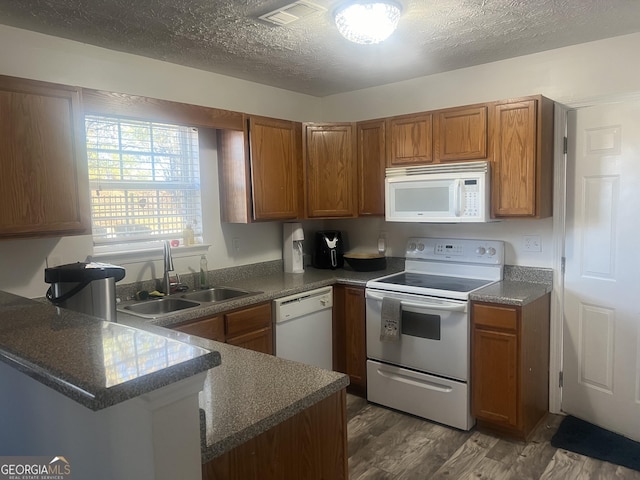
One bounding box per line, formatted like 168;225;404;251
0;292;348;480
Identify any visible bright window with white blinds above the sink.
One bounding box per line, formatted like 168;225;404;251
85;115;202;245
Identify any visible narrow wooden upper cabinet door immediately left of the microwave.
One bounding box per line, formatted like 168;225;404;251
356;120;386;216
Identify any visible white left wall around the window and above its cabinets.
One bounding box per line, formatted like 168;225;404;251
0;25;321;297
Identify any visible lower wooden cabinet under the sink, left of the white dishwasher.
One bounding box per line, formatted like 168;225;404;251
173;302;273;355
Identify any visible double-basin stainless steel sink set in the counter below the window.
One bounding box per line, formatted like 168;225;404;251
118;287;261;318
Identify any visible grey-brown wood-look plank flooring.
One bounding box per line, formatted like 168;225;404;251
347;395;640;480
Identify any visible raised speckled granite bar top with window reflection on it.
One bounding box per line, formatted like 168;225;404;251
0;291;220;410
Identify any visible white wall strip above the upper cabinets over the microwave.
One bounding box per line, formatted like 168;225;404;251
322;33;640;122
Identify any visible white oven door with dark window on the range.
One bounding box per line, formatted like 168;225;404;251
366;288;469;382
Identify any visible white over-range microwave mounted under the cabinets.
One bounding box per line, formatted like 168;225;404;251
385;161;491;223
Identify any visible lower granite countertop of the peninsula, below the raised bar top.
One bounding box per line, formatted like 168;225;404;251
122;316;349;463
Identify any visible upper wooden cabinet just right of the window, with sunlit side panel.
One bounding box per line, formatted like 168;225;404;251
218;116;302;223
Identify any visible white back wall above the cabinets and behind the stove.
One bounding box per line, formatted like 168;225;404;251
323;33;640;267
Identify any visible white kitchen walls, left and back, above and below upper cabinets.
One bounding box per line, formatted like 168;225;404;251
0;26;640;297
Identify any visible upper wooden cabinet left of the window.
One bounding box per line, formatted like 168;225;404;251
0;76;91;238
